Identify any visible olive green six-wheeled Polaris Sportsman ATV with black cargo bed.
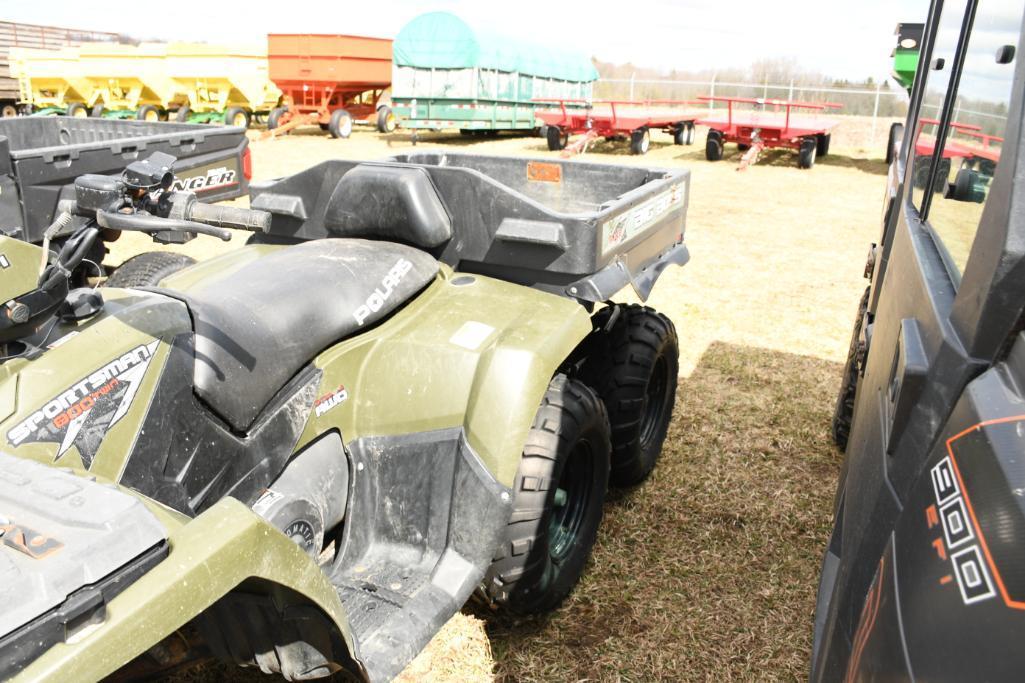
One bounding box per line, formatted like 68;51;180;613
0;153;689;681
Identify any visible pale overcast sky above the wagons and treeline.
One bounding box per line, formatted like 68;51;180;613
0;0;929;79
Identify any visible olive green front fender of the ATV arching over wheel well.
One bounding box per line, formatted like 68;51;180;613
14;497;353;681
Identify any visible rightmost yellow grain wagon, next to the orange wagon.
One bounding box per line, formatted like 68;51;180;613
165;43;281;126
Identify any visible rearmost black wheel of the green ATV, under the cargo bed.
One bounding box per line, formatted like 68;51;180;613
580;304;680;486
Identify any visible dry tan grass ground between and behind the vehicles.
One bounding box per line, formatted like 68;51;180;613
148;119;889;682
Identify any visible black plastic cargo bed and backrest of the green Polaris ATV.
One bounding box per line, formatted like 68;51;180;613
250;153;690;303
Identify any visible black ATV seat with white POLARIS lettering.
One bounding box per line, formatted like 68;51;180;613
174;239;438;432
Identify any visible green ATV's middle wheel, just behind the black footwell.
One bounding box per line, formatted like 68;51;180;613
483;375;610;614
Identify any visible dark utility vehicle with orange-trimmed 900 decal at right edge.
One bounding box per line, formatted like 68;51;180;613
811;0;1025;681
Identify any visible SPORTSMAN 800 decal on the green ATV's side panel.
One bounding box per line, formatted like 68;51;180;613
7;342;160;469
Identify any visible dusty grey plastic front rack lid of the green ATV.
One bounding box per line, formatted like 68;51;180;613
0;453;167;680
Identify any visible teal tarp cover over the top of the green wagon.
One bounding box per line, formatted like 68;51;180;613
393;12;598;83
